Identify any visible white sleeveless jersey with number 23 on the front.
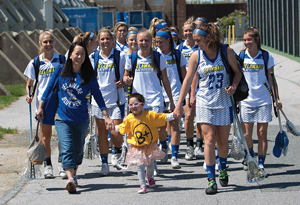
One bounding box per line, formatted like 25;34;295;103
196;50;231;109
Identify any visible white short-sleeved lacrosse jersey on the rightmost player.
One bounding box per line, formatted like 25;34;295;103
240;50;275;107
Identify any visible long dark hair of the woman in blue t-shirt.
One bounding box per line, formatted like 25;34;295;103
61;42;95;85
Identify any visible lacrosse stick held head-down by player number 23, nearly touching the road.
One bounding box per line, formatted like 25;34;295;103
230;91;266;183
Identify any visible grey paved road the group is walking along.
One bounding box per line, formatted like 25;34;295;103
0;43;300;204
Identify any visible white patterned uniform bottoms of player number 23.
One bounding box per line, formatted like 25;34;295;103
195;107;233;126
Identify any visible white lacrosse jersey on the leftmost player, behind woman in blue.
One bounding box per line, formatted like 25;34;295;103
24;52;60;109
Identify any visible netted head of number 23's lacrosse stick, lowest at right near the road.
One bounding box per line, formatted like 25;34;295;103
247;155;266;183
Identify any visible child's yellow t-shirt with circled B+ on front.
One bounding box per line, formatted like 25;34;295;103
118;111;167;146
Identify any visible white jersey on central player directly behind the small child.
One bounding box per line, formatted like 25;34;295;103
125;51;167;108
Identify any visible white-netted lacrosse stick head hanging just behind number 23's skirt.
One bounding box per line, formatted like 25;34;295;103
229;120;245;160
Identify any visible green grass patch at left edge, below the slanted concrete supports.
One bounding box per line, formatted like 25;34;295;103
0;84;26;110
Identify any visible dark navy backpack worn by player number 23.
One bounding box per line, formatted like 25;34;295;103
221;44;249;103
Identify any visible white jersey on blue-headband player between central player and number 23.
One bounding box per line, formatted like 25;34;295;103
161;52;187;102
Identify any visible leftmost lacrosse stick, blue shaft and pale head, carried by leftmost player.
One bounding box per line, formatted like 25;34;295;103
24;85;42;179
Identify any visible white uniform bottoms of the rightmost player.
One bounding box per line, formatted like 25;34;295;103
240;104;272;123
